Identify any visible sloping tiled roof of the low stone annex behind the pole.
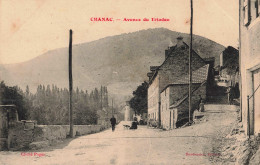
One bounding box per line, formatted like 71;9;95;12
172;64;209;84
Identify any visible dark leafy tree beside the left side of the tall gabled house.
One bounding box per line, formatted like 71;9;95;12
130;81;148;115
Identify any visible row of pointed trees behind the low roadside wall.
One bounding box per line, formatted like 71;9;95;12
0;82;108;125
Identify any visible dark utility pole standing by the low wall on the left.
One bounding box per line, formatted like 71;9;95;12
69;30;73;138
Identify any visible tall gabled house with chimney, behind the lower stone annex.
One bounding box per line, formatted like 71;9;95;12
147;37;206;125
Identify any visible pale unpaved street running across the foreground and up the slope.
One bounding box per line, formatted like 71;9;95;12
0;105;237;165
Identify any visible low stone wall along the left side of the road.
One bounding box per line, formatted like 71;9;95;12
7;122;107;150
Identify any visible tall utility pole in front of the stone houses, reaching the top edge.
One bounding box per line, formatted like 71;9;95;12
189;0;193;123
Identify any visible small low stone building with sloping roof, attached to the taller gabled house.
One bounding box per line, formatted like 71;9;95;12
160;64;209;130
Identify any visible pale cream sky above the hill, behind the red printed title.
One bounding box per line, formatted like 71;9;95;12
0;0;239;64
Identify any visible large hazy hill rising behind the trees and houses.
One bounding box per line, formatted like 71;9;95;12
0;28;225;105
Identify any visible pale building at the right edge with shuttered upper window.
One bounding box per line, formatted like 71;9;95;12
239;0;260;135
